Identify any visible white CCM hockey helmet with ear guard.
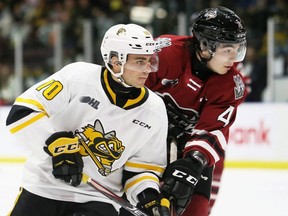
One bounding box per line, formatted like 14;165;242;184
101;24;156;77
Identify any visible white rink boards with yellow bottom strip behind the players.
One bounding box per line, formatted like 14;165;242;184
0;103;288;169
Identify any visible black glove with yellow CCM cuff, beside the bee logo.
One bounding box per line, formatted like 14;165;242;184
44;131;83;187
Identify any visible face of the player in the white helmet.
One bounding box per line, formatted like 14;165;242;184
122;54;158;88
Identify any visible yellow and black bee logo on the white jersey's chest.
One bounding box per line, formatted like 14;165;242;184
76;119;125;176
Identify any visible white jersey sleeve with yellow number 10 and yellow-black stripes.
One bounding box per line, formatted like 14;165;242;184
8;63;101;158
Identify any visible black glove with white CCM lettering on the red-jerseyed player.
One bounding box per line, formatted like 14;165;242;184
161;151;207;215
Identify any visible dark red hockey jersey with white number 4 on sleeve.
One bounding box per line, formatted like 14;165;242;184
146;35;246;165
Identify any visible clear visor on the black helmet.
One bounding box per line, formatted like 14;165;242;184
214;43;246;62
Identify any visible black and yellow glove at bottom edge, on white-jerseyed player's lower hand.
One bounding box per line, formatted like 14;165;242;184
137;188;170;216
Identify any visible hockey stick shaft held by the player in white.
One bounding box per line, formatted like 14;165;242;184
82;173;149;216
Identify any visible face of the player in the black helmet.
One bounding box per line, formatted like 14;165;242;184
207;43;240;74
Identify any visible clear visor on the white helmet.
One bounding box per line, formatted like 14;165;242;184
124;53;159;73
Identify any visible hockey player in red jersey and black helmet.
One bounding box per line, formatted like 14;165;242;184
146;7;246;216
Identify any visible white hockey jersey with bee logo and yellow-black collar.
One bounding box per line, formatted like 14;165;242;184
8;62;168;208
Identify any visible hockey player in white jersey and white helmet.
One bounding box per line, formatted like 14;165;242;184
6;24;168;216
